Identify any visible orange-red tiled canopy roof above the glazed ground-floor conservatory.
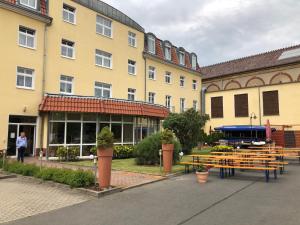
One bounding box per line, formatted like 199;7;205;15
39;94;169;118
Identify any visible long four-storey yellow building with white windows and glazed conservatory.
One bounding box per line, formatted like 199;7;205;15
0;0;201;156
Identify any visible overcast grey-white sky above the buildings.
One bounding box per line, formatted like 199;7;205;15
104;0;300;66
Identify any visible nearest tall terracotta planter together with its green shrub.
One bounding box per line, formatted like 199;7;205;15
97;127;114;189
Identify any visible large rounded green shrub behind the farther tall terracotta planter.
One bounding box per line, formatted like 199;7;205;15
135;133;181;165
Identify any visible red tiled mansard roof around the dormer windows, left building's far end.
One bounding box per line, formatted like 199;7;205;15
145;33;200;72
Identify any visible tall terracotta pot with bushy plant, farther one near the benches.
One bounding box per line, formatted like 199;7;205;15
161;129;174;173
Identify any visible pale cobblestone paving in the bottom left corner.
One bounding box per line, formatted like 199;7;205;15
0;177;90;223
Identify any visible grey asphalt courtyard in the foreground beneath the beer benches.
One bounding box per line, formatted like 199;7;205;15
4;163;300;225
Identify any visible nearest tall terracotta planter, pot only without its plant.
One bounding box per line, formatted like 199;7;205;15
97;148;113;189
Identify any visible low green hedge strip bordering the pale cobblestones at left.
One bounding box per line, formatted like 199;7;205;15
4;162;95;188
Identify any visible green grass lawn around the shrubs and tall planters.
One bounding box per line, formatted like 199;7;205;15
66;149;210;175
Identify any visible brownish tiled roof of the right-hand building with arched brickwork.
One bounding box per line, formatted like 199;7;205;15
201;45;300;80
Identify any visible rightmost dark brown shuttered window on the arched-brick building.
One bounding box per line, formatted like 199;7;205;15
263;91;279;116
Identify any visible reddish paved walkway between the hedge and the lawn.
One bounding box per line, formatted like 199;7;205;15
25;158;163;188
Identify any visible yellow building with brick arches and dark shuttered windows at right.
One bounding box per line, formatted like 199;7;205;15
202;46;300;147
